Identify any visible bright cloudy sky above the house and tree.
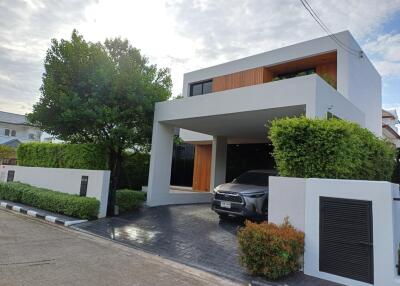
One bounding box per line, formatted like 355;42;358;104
0;0;400;115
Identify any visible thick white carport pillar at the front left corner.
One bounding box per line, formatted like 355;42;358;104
147;120;174;206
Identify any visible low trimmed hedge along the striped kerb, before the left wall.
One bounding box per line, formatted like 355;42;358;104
0;182;100;219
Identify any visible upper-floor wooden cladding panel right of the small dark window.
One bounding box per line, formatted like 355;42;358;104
213;67;272;92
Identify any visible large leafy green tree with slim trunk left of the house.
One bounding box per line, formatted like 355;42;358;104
28;30;172;213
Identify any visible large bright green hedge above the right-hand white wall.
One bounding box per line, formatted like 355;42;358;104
269;117;395;180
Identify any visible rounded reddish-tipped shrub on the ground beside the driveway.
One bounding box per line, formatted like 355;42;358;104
238;220;304;279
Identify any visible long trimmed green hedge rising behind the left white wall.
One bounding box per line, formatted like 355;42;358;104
17;143;108;170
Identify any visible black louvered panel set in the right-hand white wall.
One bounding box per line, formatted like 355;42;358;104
319;197;374;284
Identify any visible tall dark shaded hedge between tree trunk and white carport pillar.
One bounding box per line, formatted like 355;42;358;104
118;152;150;190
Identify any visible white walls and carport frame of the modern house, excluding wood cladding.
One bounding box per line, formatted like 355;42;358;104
148;31;382;206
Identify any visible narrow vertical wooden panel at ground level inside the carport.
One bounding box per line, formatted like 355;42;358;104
192;144;212;192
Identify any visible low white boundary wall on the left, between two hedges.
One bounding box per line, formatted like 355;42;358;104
0;165;110;218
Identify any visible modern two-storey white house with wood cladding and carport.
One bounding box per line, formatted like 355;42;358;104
147;31;382;206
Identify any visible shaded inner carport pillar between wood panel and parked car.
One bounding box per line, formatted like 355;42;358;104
210;136;227;191
